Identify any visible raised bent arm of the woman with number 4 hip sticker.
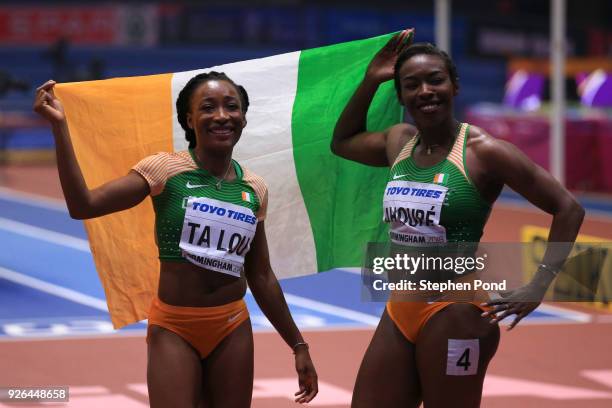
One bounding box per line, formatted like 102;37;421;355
331;29;414;167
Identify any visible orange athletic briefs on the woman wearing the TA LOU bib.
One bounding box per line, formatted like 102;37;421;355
147;297;249;358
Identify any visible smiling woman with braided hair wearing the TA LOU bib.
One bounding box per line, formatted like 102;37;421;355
34;71;318;408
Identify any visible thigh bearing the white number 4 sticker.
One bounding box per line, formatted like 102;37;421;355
416;303;499;408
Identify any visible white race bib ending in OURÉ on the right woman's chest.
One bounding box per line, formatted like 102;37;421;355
383;180;448;246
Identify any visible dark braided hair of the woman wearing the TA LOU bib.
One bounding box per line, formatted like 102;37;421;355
176;71;249;149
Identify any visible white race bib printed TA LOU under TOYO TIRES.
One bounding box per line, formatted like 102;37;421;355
179;197;257;276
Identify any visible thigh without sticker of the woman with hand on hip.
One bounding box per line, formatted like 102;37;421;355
351;309;421;408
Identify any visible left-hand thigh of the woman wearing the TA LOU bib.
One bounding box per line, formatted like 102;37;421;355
147;325;202;408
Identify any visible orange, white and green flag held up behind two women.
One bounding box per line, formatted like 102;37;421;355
56;35;402;327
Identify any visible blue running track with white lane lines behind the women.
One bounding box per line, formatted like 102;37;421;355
0;189;584;339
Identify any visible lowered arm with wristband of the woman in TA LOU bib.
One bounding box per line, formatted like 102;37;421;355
245;221;318;403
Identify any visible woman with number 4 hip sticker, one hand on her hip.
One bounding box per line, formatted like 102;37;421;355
331;30;584;408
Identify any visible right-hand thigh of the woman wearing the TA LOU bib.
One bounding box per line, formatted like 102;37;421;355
202;319;253;408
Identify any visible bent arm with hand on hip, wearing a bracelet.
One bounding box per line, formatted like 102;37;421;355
476;135;585;329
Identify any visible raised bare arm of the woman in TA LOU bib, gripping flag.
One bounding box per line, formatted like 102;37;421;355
33;81;149;219
